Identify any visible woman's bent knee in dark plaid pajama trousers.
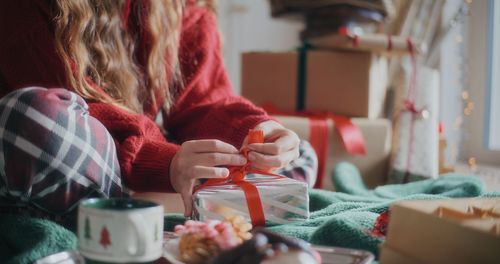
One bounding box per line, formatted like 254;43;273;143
0;87;126;214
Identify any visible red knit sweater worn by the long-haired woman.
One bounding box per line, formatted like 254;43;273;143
0;0;269;192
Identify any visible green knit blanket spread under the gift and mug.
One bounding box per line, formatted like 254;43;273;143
0;163;500;263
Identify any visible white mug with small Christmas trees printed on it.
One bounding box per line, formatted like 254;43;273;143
78;198;163;263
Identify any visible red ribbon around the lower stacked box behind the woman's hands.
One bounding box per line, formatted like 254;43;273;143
264;104;366;188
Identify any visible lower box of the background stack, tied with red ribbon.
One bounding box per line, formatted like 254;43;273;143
274;116;392;190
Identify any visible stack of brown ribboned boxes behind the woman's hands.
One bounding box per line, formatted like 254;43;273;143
242;1;398;190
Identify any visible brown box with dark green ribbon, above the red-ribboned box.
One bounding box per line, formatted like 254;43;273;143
242;50;387;118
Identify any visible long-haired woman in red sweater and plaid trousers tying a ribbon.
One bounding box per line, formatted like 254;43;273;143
0;0;308;219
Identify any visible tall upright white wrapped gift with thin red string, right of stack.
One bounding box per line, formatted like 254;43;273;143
390;67;440;183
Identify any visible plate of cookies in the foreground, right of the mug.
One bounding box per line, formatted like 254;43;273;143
164;216;321;264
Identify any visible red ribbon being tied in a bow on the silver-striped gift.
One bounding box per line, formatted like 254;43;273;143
197;129;284;227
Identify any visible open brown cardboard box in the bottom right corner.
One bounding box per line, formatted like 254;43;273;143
385;198;500;263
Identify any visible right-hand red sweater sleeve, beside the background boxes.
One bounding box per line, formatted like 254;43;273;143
164;6;270;147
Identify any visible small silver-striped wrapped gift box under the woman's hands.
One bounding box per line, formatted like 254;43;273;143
193;174;309;225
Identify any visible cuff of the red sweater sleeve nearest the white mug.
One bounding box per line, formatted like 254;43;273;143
131;140;180;192
